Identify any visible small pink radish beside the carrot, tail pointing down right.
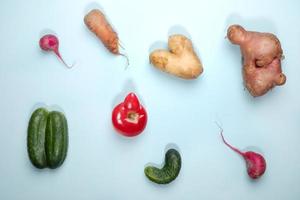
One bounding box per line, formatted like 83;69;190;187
40;34;73;68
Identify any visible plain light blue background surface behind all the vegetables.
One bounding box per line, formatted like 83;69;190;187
0;0;300;200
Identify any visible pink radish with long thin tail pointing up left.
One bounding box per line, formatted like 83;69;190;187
219;126;267;179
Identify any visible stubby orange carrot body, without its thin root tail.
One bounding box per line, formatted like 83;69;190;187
84;9;120;55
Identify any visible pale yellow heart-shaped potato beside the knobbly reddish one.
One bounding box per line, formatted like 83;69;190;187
149;35;203;79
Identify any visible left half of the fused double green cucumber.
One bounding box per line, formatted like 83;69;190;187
27;108;48;169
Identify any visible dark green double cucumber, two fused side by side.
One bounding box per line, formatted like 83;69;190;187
27;108;68;169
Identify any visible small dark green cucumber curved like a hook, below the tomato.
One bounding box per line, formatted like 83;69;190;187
144;149;181;184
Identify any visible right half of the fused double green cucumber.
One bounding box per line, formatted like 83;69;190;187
45;111;68;169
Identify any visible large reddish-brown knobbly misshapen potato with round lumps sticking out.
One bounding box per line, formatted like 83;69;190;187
227;25;286;97
